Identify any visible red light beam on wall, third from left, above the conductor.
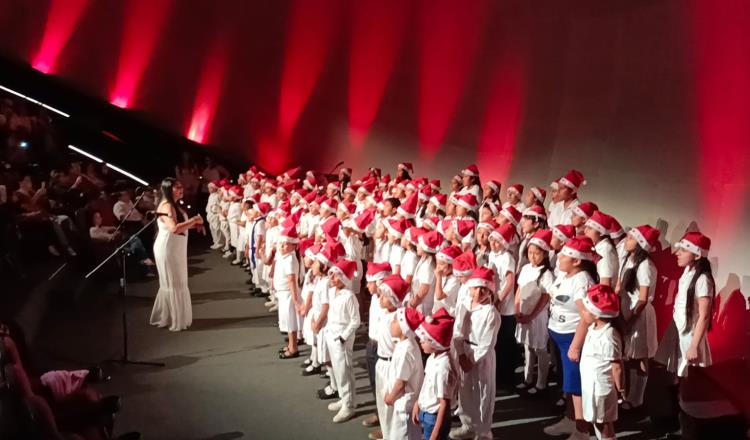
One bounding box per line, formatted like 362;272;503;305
186;35;229;144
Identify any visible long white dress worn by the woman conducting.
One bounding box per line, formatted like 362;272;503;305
150;209;193;331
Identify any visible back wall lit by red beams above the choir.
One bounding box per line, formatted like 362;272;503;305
0;0;750;292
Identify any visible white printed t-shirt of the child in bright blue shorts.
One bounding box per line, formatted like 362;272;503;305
548;270;594;334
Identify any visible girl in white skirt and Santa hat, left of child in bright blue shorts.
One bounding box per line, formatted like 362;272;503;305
515;229;555;394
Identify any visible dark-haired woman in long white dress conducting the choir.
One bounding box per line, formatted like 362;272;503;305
150;177;203;332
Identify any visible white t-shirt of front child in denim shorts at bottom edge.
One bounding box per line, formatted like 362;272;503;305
419;351;458;414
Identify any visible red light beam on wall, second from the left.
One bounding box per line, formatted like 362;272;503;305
109;0;172;108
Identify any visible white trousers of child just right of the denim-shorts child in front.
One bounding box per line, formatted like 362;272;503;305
458;350;495;438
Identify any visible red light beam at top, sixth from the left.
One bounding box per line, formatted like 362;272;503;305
418;0;488;160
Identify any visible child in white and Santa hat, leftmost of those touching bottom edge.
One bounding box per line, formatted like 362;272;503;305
372;274;411;439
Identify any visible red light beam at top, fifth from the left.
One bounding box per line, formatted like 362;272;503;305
349;0;409;150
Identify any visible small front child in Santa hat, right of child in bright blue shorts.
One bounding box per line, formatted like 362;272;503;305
581;284;624;440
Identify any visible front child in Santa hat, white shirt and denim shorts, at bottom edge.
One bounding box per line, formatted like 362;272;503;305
411;307;458;440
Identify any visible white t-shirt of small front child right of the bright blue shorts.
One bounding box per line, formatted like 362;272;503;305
581;323;622;396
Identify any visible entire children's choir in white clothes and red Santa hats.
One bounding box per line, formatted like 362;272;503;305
206;163;715;440
